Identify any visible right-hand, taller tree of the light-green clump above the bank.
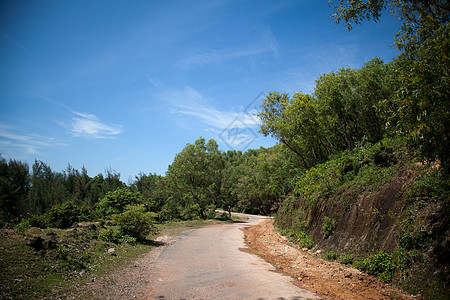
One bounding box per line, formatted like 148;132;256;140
314;58;396;148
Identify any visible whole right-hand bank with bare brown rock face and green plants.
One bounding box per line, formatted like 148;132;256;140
275;140;450;299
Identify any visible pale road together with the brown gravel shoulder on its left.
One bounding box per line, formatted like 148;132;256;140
75;216;320;300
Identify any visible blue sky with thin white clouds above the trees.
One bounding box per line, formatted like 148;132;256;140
0;0;399;182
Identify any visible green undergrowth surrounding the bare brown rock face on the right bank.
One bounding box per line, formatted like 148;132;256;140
275;139;450;299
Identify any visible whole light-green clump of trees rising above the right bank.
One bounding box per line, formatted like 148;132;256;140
258;58;395;169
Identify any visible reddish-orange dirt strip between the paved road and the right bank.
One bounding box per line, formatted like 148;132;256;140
244;219;416;300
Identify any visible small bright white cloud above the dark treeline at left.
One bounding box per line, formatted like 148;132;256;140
70;111;123;138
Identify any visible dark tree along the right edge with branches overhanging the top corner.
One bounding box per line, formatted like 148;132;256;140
330;0;450;174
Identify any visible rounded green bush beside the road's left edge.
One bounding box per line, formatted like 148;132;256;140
113;204;157;241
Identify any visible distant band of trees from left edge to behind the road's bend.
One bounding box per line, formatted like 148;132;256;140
0;138;297;225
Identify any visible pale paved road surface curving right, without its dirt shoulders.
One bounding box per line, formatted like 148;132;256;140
150;215;320;300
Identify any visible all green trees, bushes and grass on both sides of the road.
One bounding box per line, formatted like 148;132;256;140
0;0;450;299
